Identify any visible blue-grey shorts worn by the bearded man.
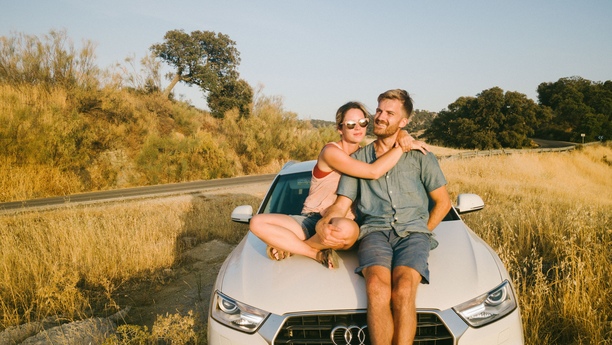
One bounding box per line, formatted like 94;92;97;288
355;230;431;284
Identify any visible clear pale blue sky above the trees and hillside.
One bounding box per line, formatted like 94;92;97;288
0;0;612;121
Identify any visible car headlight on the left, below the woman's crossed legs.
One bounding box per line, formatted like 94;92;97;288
210;291;270;333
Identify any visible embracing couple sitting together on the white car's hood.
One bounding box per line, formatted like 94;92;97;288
251;89;451;344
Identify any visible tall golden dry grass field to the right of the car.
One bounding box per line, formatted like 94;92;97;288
442;146;612;344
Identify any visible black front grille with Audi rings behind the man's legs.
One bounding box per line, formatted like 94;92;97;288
274;313;454;345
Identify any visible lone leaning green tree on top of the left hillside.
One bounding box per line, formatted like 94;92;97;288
150;30;240;97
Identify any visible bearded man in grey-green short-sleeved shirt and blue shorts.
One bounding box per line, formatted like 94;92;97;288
316;89;451;345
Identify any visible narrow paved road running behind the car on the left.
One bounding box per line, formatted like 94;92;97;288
0;174;276;212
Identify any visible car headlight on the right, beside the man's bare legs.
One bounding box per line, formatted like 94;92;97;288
453;280;517;327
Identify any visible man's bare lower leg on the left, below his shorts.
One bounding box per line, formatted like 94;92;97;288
363;266;394;345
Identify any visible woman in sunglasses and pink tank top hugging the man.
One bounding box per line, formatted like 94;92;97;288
250;102;428;269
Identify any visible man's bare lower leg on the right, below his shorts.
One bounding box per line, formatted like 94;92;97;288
391;266;421;345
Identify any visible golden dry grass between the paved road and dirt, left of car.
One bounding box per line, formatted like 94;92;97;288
0;195;260;328
